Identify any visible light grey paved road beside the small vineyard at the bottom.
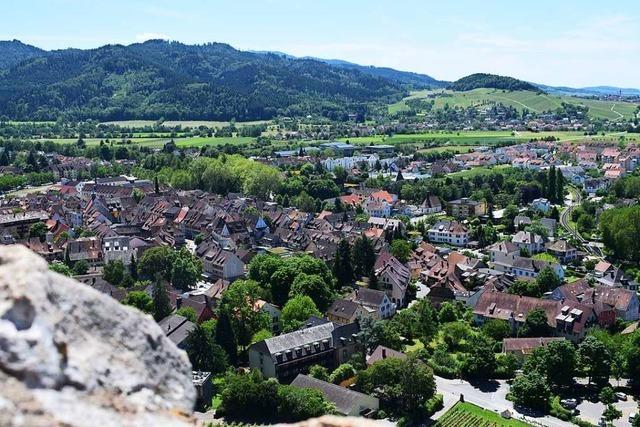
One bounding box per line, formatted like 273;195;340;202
433;376;573;427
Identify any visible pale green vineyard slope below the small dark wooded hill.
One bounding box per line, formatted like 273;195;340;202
389;89;636;120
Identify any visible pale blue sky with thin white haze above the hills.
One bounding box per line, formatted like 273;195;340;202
5;0;640;87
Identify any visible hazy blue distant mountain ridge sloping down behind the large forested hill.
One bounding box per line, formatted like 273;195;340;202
251;51;449;89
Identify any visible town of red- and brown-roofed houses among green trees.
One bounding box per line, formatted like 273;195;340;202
0;128;640;426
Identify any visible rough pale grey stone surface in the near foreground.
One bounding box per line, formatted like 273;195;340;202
0;246;195;426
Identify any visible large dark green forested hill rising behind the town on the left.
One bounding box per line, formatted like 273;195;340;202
0;40;406;120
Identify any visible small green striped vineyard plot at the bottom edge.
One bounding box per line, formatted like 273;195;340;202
435;402;530;427
